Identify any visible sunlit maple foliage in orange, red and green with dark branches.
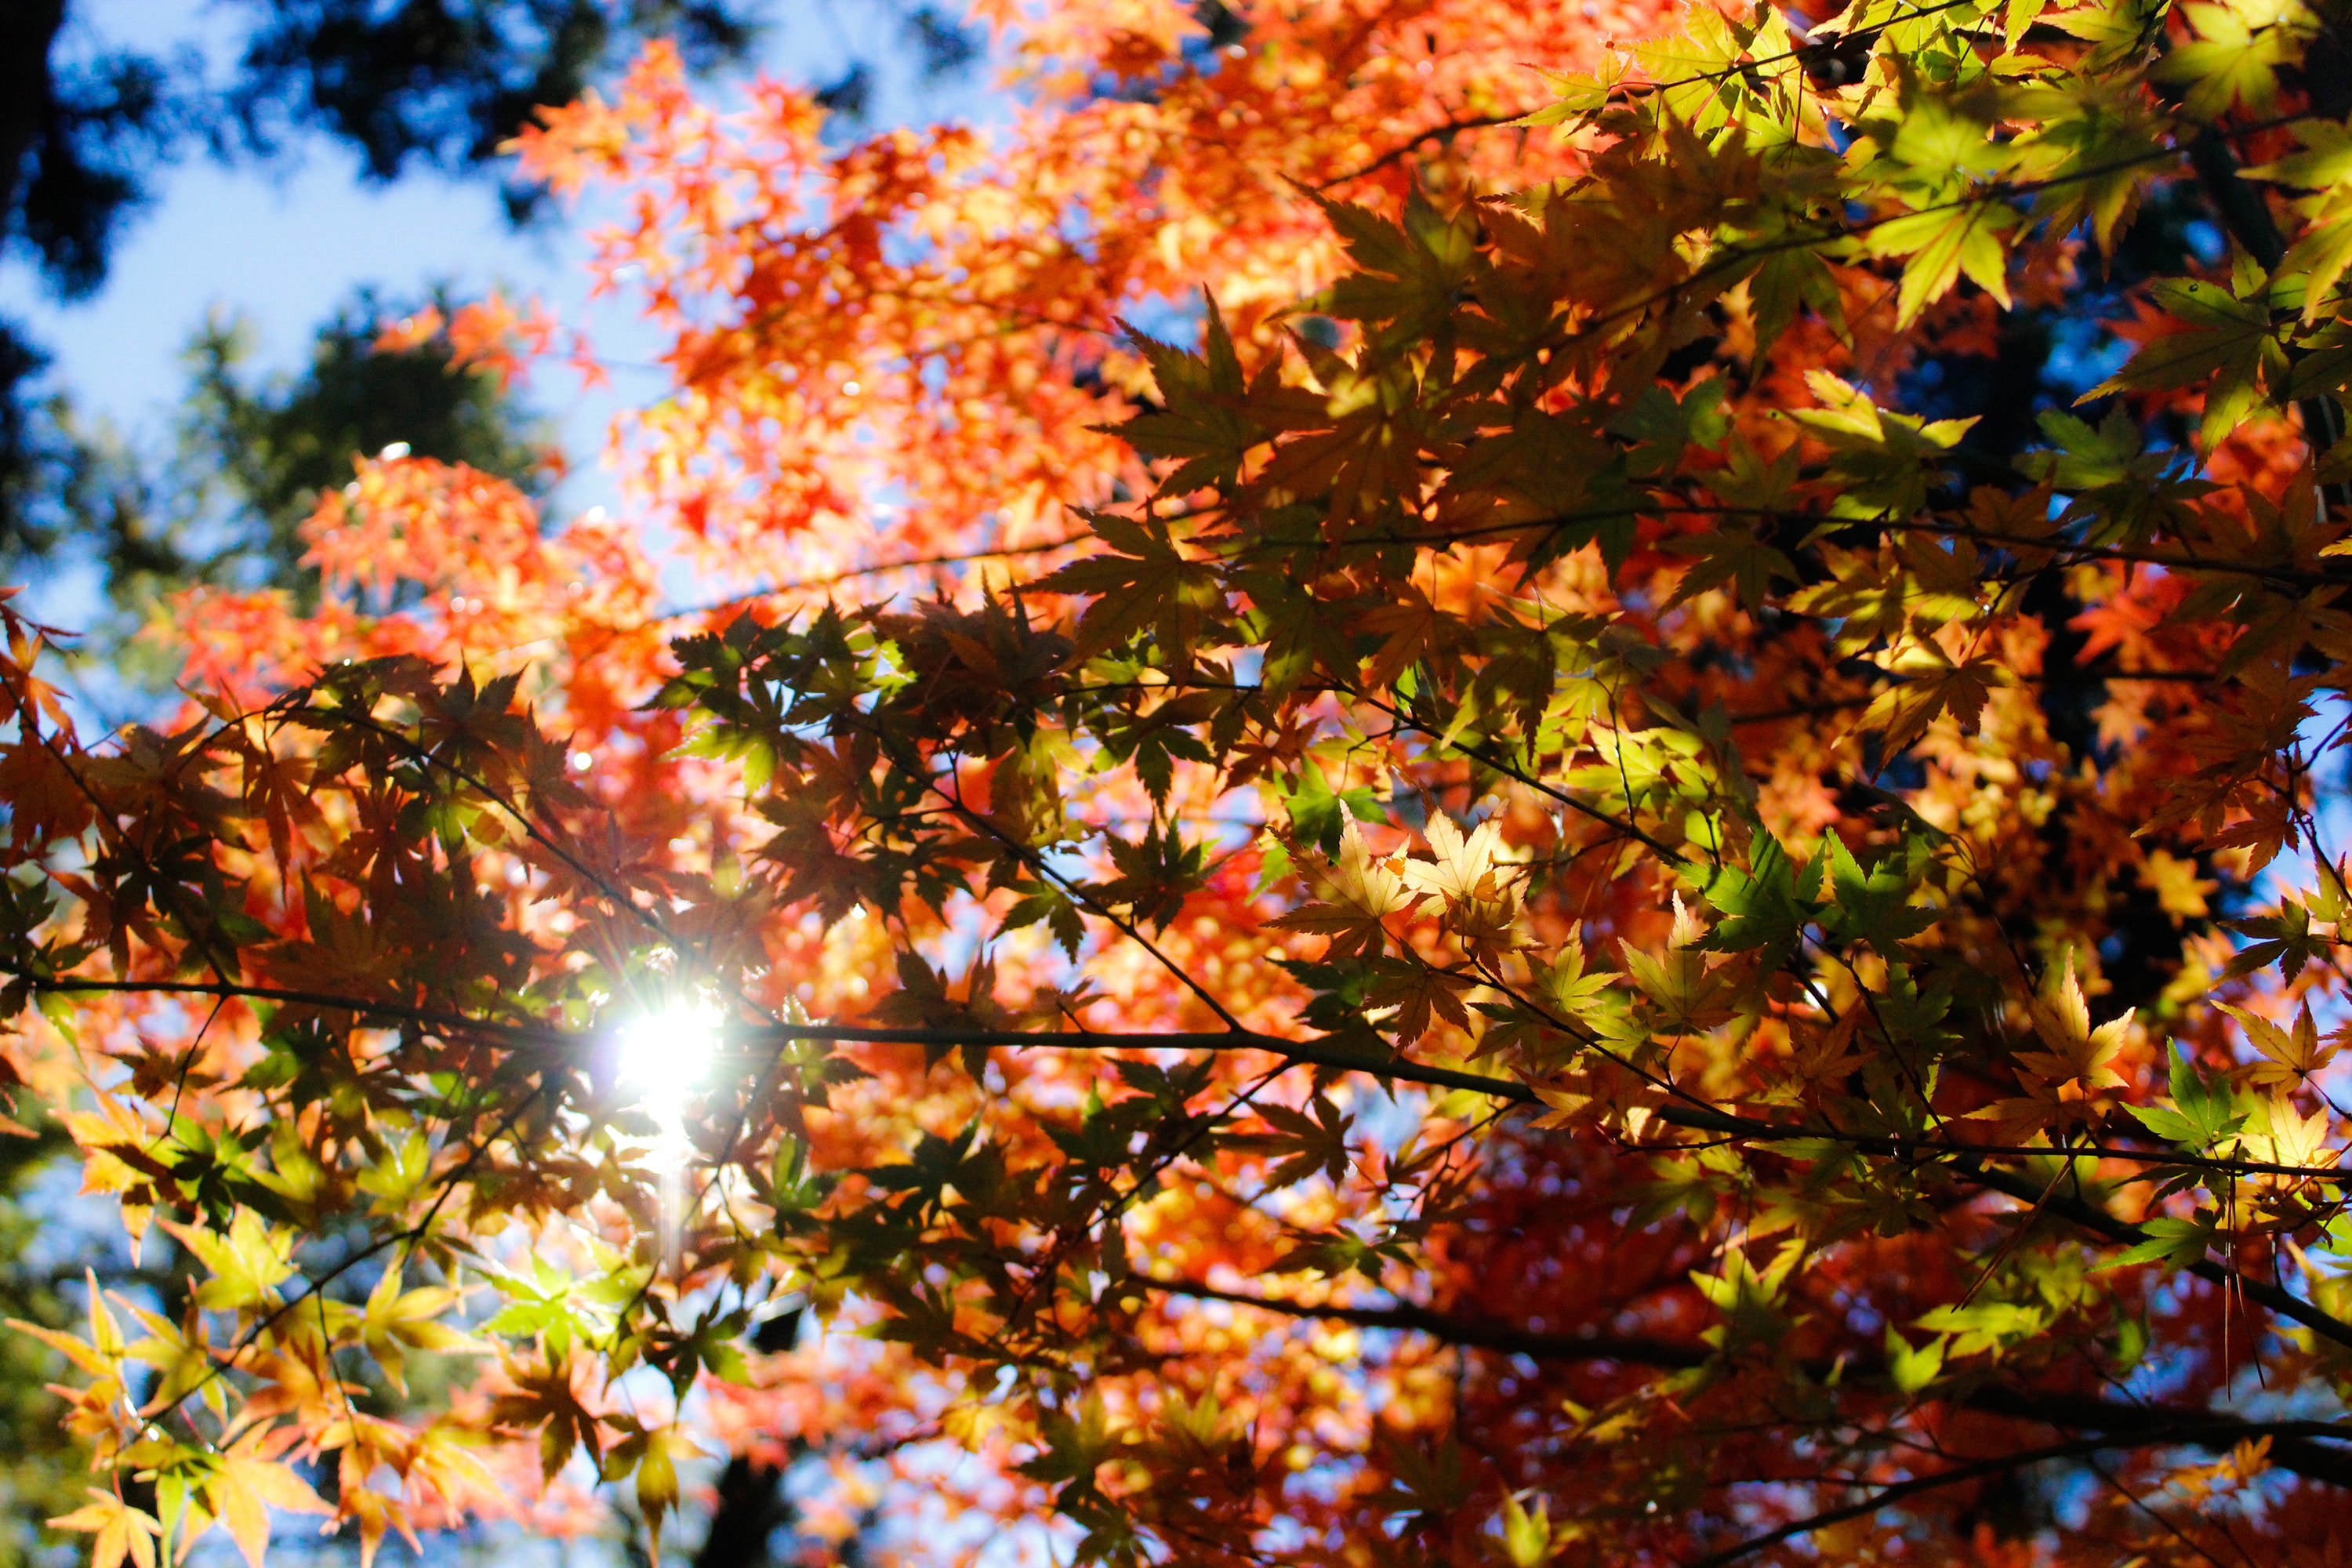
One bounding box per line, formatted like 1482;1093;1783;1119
0;0;2352;1568
